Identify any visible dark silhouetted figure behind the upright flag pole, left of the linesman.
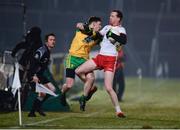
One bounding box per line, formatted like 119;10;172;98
11;26;42;108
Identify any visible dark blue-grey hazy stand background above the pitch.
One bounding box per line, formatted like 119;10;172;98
0;0;180;78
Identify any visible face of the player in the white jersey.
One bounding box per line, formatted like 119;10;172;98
109;12;120;26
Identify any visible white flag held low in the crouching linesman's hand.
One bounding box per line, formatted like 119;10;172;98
36;83;58;97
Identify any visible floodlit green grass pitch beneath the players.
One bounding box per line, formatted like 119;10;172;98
0;78;180;129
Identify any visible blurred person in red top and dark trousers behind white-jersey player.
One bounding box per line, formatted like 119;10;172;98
113;49;125;101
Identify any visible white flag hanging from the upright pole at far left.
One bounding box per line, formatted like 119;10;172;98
11;62;21;96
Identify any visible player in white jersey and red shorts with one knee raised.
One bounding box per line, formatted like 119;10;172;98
76;10;127;117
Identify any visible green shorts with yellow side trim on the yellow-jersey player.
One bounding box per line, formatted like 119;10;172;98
65;55;86;70
